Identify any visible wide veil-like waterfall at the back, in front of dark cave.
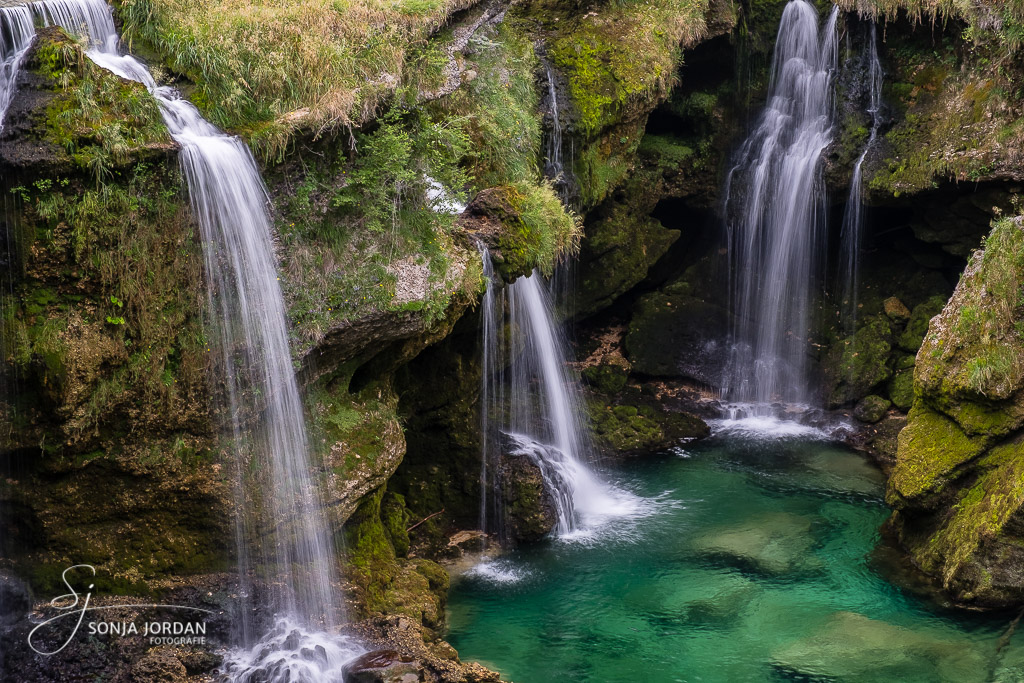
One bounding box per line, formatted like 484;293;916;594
722;0;839;405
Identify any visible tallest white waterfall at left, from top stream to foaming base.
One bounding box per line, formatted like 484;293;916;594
0;0;354;682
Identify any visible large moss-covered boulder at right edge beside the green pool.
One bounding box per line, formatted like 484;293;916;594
887;218;1024;605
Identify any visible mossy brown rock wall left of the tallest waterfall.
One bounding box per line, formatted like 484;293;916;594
0;28;232;594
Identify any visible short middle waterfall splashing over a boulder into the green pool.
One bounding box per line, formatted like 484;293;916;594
480;249;642;538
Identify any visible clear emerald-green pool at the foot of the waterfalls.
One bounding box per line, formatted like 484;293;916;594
449;436;1024;683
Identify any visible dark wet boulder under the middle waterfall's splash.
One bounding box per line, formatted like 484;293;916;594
498;453;558;542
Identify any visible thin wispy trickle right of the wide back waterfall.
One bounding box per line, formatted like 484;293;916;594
839;23;884;333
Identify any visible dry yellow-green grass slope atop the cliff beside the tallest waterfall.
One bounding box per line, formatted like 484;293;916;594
117;0;468;150
